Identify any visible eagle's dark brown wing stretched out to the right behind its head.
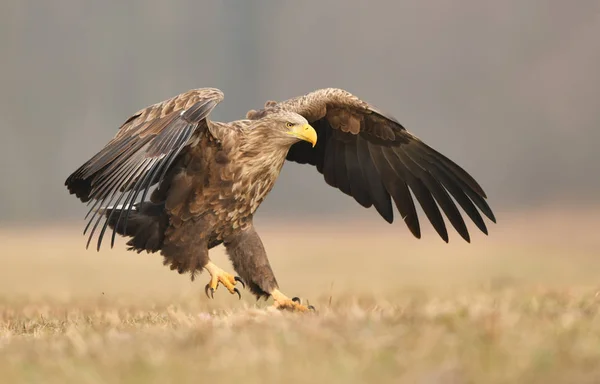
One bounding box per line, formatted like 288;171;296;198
248;88;496;242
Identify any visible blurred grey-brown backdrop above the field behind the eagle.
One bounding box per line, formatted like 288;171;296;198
0;0;600;296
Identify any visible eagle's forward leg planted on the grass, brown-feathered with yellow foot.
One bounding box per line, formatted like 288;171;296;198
224;225;314;312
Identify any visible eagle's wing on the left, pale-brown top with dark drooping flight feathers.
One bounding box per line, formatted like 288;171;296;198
65;88;223;249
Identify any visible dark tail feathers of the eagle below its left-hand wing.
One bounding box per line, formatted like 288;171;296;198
99;202;168;253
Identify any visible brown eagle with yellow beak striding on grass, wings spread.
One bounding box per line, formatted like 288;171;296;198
65;88;496;312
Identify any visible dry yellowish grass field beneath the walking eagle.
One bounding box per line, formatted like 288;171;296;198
0;210;600;383
